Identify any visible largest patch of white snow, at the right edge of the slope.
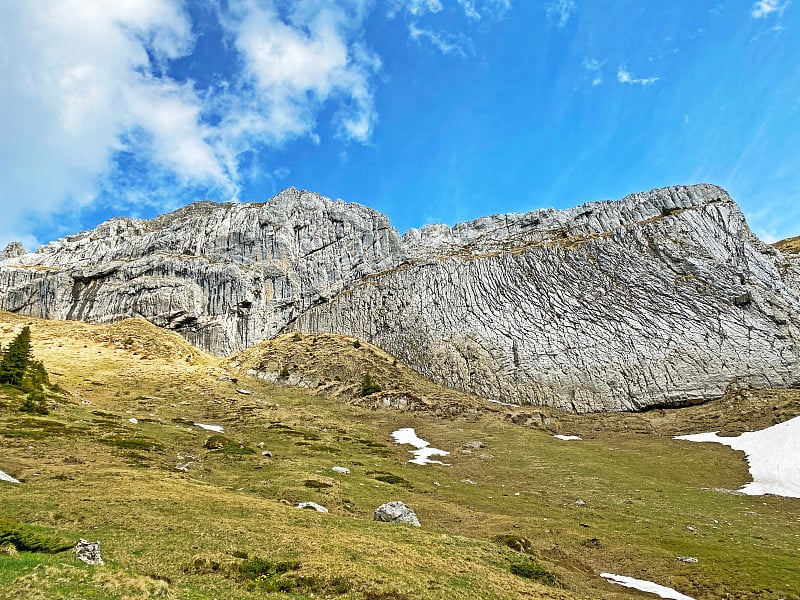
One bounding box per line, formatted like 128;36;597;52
675;417;800;498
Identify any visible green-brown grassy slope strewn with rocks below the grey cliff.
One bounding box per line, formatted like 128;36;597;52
0;313;800;599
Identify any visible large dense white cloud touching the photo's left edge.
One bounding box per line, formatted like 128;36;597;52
0;0;232;243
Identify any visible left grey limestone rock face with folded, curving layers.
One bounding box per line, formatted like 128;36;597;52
0;188;401;355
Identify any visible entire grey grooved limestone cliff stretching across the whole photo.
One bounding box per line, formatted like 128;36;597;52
0;185;800;412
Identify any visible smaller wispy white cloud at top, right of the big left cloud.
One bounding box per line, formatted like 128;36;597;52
222;1;381;147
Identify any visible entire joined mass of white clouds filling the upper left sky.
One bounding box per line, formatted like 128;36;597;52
0;0;381;248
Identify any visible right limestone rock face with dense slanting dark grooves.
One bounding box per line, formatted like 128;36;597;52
296;185;800;412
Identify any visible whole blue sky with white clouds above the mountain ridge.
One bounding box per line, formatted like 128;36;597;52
0;0;800;250
